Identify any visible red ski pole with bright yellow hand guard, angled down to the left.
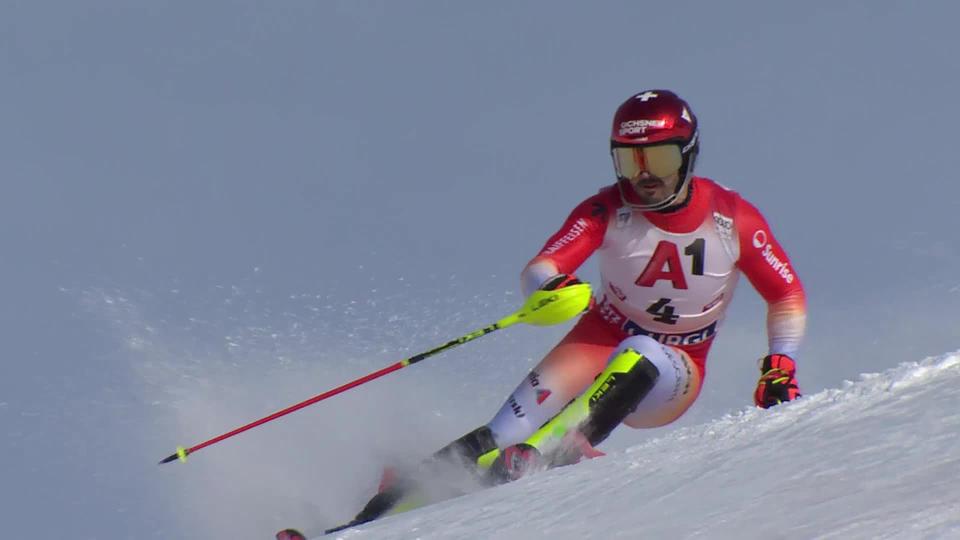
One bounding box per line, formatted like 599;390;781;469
160;283;590;465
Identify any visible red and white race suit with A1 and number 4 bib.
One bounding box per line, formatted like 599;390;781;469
489;177;806;444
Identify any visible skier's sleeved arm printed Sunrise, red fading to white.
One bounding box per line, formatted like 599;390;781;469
736;199;807;358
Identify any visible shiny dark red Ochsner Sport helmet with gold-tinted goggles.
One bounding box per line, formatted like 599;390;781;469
610;90;700;210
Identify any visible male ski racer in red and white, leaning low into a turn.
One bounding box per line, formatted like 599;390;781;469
331;90;806;530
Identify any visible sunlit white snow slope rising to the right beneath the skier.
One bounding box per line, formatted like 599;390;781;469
339;352;960;539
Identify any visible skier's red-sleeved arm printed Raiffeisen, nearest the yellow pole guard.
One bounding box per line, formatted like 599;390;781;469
520;192;609;295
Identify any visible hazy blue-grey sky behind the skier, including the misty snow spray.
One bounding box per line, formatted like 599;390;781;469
0;0;960;539
